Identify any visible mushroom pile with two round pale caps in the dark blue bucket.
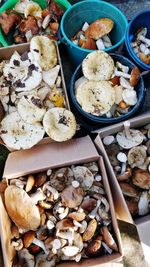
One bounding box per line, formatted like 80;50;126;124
74;51;140;118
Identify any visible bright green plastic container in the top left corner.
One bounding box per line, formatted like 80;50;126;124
0;0;71;46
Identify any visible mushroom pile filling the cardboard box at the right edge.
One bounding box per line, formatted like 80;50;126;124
103;121;150;217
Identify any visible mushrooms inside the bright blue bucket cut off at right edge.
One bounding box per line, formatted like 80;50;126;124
131;28;150;65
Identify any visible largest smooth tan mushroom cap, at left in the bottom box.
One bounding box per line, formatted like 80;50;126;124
5;185;40;230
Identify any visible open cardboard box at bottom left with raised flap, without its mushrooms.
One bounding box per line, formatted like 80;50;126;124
0;136;122;267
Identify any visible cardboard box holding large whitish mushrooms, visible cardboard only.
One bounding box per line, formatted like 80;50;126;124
0;42;70;150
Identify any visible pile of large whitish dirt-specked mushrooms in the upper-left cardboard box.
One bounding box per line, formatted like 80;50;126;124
0;36;76;150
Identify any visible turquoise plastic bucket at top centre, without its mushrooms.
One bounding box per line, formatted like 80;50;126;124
59;0;128;66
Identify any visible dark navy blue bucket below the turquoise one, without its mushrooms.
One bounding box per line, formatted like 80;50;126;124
70;54;145;124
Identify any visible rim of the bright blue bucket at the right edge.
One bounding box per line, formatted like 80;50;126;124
125;10;150;70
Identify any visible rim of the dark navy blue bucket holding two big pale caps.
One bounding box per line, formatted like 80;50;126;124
70;53;145;123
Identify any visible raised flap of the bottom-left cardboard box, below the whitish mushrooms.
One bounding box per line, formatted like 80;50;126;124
3;136;99;179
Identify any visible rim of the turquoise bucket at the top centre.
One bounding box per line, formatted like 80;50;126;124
60;0;128;53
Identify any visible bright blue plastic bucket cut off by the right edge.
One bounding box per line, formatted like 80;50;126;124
125;10;150;70
